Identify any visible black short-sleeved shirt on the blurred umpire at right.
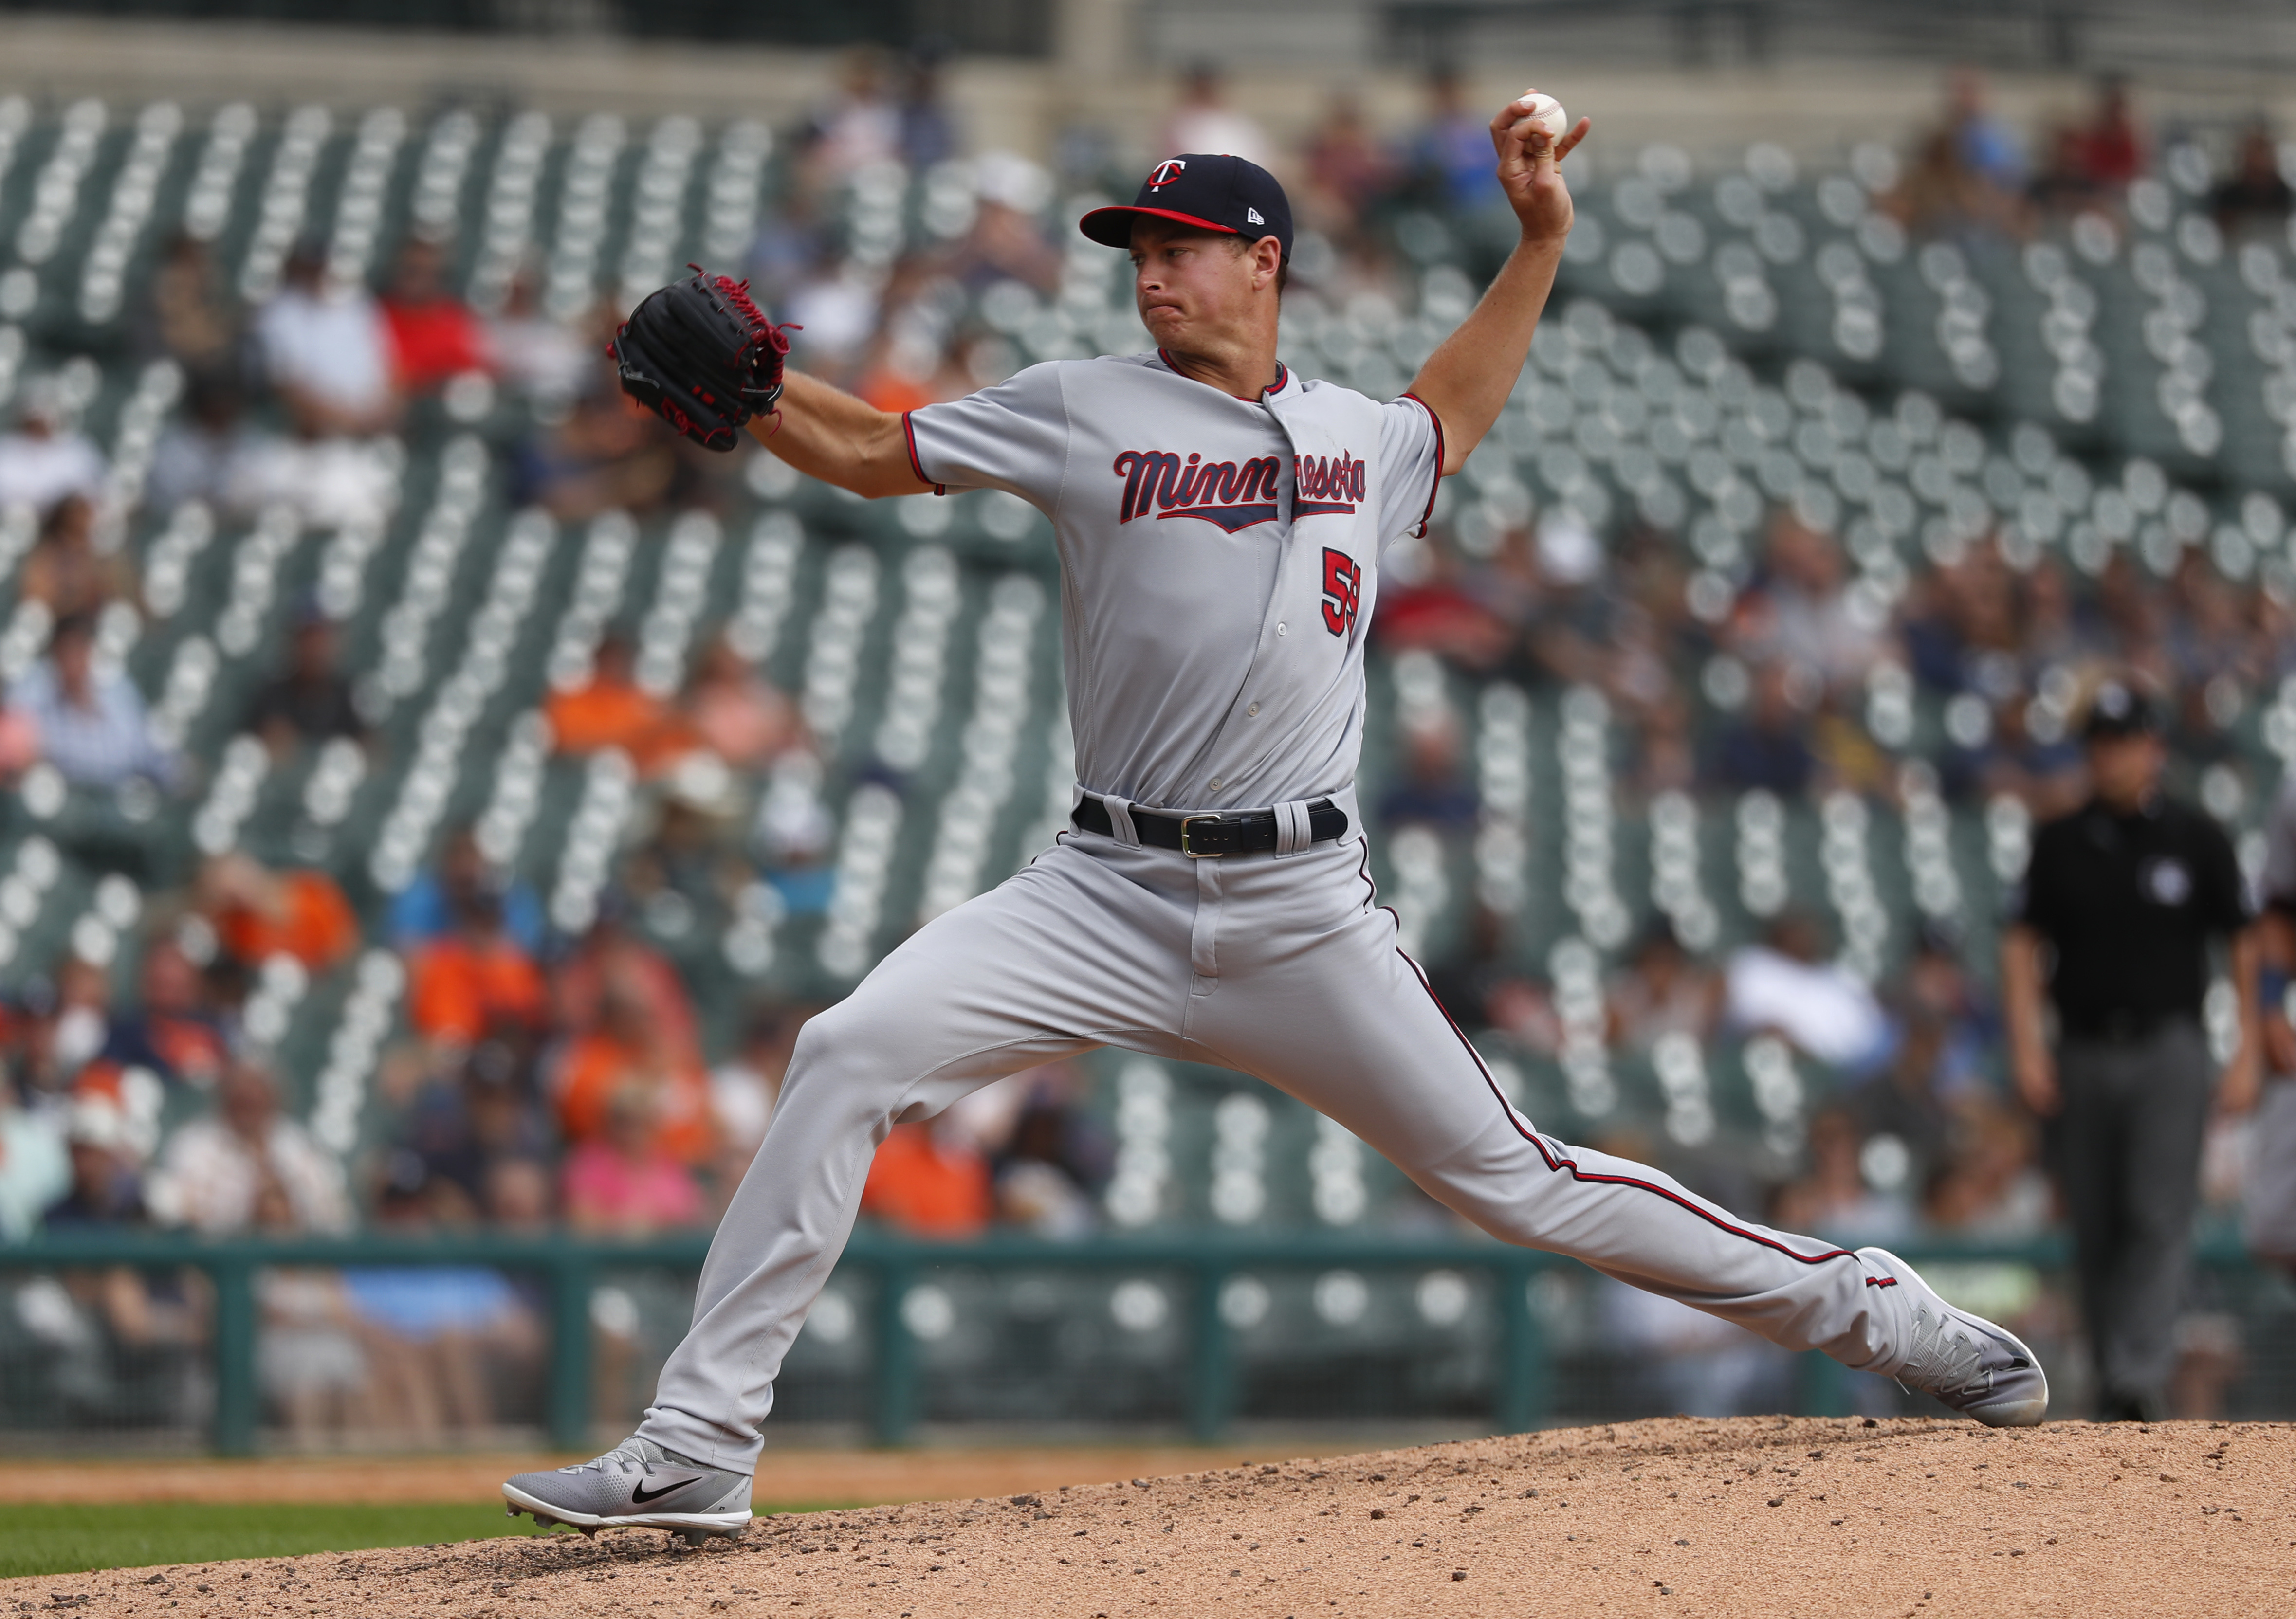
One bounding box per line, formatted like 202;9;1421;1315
2014;795;2255;1038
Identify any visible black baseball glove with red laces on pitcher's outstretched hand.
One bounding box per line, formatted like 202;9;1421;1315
606;264;794;450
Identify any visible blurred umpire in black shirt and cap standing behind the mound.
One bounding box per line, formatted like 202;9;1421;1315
2002;680;2259;1421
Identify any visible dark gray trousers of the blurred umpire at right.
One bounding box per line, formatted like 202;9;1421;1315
2053;1018;2213;1410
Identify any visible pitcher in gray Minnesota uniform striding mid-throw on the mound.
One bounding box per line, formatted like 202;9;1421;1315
503;96;2048;1541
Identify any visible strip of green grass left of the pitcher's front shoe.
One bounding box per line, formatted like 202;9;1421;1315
0;1502;569;1578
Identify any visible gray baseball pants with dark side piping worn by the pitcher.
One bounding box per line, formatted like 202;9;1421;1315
638;822;1910;1472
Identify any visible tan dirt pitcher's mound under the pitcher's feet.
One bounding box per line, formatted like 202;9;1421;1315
13;1417;2296;1619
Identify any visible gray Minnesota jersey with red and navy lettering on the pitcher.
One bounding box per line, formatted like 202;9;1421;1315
907;354;1442;811
